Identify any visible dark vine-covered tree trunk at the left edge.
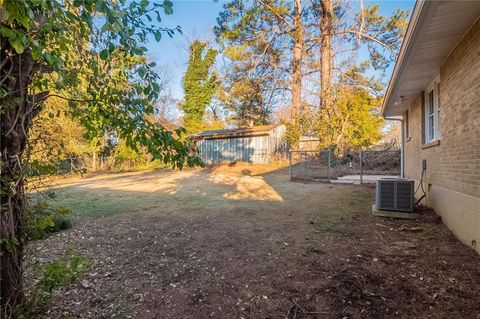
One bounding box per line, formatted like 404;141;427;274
0;37;41;318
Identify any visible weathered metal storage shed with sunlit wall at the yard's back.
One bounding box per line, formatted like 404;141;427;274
190;125;287;165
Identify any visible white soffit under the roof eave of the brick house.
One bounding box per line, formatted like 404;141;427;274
382;0;480;117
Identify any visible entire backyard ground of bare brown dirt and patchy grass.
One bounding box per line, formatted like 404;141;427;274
28;167;480;319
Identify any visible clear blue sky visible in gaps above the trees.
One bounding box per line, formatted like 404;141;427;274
147;0;415;99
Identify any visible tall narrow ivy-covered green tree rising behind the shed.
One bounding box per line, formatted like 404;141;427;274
179;40;219;133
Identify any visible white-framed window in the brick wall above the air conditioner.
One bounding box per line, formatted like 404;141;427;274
424;77;440;143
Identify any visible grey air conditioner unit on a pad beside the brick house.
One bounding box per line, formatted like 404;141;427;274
375;178;414;212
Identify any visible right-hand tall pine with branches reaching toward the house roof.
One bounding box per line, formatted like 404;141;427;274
312;0;408;120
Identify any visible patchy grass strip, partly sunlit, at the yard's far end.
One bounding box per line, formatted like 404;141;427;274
46;166;362;217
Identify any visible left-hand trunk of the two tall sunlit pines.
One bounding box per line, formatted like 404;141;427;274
291;0;304;120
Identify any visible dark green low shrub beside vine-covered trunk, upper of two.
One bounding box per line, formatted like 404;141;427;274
26;202;72;240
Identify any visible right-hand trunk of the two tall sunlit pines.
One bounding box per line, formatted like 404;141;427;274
320;0;333;114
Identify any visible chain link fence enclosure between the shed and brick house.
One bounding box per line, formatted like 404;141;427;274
289;149;401;184
